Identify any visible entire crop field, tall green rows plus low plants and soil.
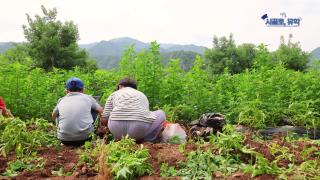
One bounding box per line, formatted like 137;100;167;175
0;44;320;179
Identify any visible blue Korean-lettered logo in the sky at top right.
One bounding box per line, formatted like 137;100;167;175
261;12;302;27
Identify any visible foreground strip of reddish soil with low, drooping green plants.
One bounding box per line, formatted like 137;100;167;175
0;118;320;179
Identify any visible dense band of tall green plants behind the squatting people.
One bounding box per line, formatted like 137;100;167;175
0;42;320;128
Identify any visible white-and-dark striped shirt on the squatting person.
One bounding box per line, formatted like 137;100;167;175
102;87;156;123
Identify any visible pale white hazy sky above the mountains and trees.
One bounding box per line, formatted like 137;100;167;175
0;0;320;51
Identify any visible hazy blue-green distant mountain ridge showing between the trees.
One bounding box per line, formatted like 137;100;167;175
0;37;320;70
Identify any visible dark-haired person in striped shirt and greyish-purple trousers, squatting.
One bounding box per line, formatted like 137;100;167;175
101;77;166;142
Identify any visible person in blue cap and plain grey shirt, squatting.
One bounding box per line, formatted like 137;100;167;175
52;77;103;146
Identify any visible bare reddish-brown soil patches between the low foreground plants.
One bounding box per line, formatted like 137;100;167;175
0;131;320;180
